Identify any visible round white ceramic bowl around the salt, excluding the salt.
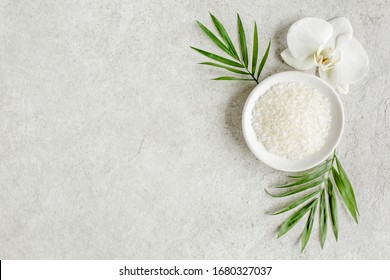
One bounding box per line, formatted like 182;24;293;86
242;71;344;172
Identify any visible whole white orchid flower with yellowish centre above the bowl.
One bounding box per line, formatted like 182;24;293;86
281;17;369;93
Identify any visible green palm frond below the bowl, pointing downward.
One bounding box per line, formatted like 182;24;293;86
266;152;359;251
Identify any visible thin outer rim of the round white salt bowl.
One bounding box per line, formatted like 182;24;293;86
241;71;345;172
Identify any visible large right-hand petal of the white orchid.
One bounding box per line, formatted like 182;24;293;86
332;34;369;84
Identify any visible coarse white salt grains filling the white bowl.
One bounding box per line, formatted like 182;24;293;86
252;82;332;160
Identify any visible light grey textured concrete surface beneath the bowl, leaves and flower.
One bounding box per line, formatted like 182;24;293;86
0;0;390;259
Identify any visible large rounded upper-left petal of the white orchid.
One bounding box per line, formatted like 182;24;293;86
287;17;333;61
